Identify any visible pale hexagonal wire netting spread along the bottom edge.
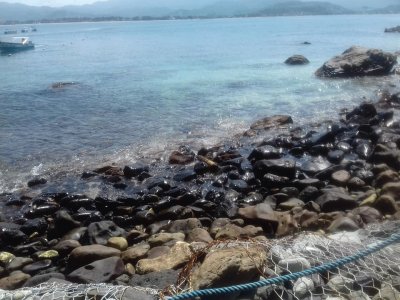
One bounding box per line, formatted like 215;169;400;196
0;221;400;300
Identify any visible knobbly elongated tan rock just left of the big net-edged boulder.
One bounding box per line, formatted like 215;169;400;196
136;242;192;274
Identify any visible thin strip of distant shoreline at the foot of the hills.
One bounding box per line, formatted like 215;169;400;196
0;13;399;26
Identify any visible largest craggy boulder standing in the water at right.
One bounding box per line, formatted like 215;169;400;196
315;46;397;78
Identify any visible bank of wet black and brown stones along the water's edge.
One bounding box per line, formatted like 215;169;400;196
0;48;400;299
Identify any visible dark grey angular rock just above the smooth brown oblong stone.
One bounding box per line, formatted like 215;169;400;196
81;221;126;245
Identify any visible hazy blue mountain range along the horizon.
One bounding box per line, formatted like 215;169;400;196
0;0;399;23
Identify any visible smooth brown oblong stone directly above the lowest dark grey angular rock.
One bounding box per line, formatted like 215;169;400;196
68;245;121;269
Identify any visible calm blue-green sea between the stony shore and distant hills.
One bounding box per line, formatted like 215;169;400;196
0;15;400;193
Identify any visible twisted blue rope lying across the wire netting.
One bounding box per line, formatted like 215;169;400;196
169;233;400;300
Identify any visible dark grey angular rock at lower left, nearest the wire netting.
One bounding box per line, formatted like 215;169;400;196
67;257;125;283
